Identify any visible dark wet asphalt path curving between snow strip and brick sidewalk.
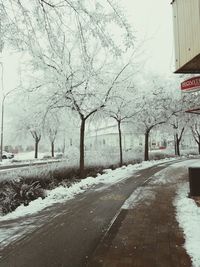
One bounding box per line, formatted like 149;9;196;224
0;160;184;267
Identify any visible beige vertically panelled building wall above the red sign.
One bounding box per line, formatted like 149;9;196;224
173;0;200;70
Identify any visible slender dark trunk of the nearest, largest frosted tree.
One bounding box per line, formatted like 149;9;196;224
79;118;85;178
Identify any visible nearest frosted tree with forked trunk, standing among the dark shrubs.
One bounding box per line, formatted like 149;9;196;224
46;60;128;177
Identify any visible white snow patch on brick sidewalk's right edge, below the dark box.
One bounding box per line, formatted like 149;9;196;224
174;183;200;267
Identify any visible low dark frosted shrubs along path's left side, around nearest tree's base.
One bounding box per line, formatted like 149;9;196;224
0;163;106;214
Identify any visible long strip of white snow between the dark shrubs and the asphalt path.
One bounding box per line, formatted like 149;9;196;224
0;159;178;248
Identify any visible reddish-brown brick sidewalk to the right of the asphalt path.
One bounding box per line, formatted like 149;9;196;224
88;168;192;267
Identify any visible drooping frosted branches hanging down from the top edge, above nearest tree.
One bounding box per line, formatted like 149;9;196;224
0;0;134;72
